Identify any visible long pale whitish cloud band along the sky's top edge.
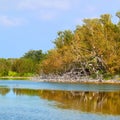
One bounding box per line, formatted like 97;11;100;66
18;0;73;10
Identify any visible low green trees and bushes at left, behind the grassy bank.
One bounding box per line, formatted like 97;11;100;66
0;50;46;77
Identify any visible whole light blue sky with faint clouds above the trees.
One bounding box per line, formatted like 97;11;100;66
0;0;120;58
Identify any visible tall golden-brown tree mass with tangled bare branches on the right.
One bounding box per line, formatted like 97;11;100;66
40;12;120;76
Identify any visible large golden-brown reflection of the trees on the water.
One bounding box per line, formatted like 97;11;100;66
13;88;120;115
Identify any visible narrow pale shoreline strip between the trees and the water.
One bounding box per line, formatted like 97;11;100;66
0;76;120;84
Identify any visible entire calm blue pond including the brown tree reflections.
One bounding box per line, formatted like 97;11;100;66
0;80;120;120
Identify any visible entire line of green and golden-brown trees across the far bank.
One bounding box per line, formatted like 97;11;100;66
0;12;120;76
